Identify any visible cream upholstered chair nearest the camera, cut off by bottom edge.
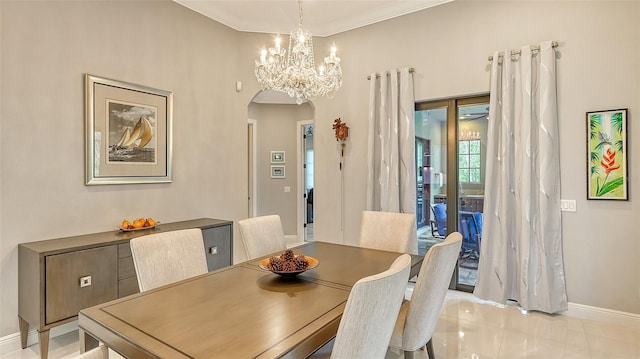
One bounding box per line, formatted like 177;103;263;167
331;254;411;359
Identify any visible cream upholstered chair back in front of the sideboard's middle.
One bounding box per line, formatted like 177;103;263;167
130;228;208;292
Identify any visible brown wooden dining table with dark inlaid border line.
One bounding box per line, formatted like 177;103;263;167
79;241;422;358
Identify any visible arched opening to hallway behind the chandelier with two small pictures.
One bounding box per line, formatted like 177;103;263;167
247;90;315;244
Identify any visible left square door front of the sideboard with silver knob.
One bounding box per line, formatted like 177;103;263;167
45;246;118;324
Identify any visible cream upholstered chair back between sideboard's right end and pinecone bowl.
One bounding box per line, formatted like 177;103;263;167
238;214;287;259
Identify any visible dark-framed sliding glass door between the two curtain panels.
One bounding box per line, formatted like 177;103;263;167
415;96;489;291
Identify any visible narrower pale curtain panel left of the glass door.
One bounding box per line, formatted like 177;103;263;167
367;68;416;213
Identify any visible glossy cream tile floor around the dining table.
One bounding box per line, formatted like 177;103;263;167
6;292;640;359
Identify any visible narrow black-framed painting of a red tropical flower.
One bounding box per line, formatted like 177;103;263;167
587;108;629;201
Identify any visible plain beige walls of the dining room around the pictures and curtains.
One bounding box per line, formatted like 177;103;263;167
0;1;640;337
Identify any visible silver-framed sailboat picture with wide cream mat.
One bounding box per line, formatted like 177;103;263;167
85;74;173;185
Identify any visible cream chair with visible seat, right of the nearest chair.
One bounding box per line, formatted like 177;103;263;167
389;232;462;359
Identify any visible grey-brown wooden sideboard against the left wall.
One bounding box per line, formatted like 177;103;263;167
18;218;233;359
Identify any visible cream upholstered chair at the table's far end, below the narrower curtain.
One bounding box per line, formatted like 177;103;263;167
359;211;418;254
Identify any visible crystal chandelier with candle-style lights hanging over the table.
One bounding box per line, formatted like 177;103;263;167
255;0;342;105
